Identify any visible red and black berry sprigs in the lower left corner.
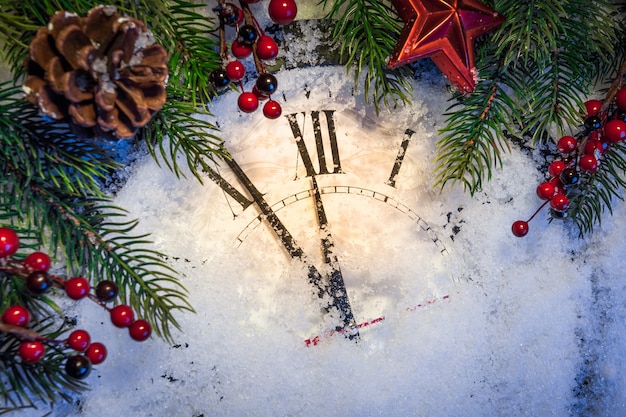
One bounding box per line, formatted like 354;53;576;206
0;227;152;379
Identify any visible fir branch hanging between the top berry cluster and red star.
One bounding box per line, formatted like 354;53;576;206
322;0;412;112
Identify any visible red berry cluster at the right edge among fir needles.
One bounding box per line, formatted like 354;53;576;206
511;87;626;237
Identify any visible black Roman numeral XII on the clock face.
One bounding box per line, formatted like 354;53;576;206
285;110;343;177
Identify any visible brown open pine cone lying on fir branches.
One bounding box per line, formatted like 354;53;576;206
24;6;168;139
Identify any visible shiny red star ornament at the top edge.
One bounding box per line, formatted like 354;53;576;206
388;0;505;93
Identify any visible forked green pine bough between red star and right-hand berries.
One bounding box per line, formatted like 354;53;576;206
435;0;618;193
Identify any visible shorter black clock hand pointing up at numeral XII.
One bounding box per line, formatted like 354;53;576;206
311;175;359;339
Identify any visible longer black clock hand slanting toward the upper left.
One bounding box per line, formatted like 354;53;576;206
225;154;358;339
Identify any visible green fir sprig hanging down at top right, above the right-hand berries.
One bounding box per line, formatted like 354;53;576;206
493;0;619;141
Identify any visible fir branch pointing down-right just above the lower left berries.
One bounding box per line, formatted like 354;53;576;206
0;179;194;341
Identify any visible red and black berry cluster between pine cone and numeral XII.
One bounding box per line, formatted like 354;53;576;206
209;0;298;119
